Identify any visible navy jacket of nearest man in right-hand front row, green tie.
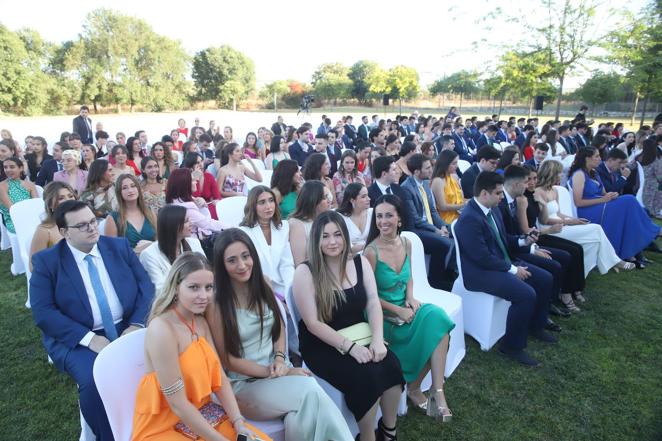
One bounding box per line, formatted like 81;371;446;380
455;199;525;283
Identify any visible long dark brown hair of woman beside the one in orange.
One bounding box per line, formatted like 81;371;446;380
214;228;284;362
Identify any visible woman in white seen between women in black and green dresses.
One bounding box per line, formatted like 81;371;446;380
337;182;372;254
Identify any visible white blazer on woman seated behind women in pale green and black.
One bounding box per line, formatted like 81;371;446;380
241;220;294;296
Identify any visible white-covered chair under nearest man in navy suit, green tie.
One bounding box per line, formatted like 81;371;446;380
451;221;510;351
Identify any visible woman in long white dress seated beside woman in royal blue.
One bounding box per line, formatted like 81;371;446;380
535;160;634;276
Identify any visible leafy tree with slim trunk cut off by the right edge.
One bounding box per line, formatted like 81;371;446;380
605;0;662;125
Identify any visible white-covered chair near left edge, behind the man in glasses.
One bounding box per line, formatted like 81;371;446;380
9;198;45;308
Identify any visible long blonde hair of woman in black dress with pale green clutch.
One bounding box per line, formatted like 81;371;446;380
308;211;350;323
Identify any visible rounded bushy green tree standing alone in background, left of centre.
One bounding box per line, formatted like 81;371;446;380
193;46;255;107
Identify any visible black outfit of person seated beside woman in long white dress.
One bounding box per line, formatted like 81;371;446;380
524;190;586;293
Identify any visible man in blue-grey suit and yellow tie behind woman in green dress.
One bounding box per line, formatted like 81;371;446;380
401;153;457;289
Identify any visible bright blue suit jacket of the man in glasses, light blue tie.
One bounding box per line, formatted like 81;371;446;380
30;236;154;371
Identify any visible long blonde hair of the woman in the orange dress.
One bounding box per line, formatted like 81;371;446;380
147;251;212;323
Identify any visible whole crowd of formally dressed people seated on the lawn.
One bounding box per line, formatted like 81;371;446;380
0;110;662;441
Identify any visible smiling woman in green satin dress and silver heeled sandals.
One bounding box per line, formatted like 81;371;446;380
364;195;455;422
